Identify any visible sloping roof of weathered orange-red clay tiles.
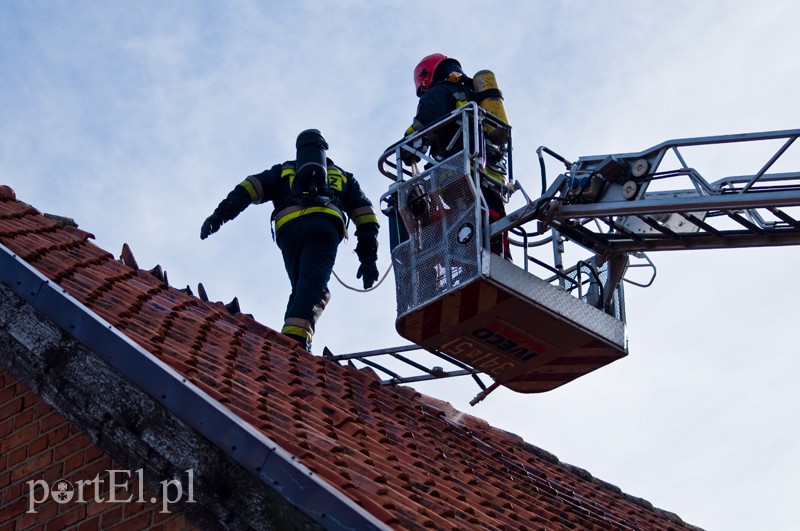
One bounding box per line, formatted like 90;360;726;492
0;187;694;529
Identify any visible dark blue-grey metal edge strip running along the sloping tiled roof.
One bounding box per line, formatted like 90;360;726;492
0;244;389;530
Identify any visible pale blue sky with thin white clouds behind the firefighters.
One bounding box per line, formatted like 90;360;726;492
0;0;800;530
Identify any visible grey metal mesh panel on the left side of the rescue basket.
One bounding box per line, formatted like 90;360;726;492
392;156;481;314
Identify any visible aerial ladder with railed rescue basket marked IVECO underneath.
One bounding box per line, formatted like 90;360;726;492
325;103;800;405
